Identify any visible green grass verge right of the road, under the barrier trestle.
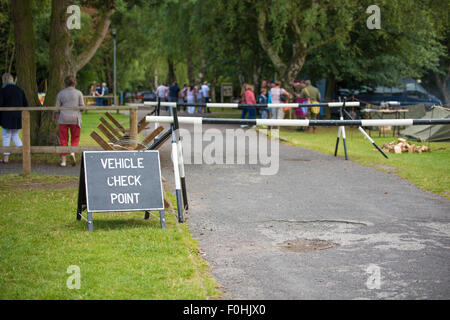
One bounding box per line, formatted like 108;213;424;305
280;127;450;199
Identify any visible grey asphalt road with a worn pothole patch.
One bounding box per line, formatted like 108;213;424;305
0;120;450;299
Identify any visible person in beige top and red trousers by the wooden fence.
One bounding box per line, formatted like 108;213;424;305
53;76;84;167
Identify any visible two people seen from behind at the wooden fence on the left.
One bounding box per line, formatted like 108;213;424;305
0;73;84;167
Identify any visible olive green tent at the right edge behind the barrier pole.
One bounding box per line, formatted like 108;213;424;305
400;107;450;142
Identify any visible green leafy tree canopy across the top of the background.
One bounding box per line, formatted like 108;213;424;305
4;0;449;104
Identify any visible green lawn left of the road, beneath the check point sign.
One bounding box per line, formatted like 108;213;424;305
0;174;220;299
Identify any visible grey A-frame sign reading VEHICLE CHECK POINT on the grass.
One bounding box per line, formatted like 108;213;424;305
77;151;165;231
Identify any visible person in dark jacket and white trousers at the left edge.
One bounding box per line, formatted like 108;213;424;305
0;73;28;163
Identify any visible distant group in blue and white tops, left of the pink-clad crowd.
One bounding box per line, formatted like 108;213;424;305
156;81;211;114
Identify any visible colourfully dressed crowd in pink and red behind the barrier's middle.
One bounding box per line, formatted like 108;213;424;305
239;80;321;133
